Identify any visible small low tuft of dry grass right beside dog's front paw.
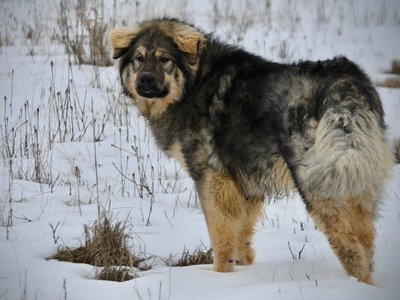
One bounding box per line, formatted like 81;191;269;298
168;246;213;267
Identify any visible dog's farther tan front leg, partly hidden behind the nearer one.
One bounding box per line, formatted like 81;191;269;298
236;197;263;265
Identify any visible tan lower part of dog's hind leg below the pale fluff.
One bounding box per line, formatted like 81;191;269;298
308;194;376;284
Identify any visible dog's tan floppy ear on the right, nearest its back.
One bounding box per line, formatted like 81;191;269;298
172;25;206;65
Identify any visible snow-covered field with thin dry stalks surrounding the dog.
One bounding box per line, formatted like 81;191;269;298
0;0;400;300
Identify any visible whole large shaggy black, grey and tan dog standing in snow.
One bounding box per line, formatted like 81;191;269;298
110;19;392;283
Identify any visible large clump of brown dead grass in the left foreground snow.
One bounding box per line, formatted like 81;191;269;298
51;216;145;281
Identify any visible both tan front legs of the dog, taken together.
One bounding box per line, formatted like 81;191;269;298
199;171;261;272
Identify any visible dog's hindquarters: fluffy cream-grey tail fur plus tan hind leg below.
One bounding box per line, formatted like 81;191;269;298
293;91;392;283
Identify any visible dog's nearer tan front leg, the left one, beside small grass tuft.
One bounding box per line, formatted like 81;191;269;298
198;171;246;272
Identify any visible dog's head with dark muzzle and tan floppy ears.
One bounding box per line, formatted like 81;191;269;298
110;19;205;118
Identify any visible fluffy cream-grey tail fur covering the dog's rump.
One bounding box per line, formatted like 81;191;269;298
298;82;393;199
